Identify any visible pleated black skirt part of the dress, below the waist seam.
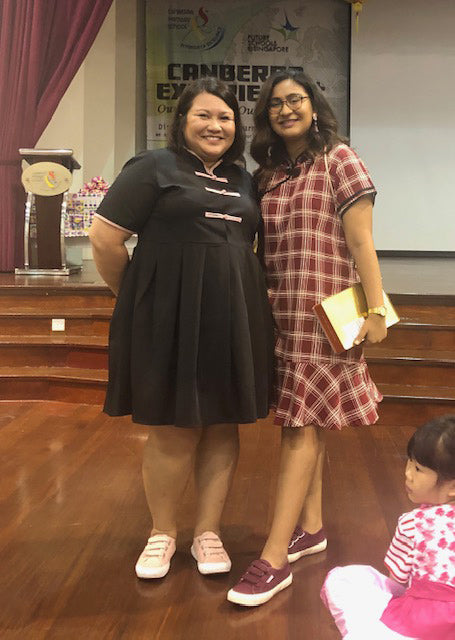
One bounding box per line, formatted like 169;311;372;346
104;243;274;427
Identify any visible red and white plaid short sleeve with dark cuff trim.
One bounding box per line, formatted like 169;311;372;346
328;144;376;216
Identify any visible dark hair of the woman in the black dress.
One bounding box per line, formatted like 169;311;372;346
168;77;245;162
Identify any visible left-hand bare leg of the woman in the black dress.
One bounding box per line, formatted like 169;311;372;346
142;425;201;538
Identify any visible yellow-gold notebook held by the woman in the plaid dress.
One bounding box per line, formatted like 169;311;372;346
313;282;400;353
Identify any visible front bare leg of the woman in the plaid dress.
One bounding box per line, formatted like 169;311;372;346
261;426;322;567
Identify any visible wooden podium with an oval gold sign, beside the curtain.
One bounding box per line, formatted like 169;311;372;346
15;149;81;276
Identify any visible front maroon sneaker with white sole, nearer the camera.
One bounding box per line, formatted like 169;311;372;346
227;558;292;607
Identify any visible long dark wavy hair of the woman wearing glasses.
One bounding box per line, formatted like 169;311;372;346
250;70;346;181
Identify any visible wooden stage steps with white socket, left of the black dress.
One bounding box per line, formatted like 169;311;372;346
0;262;115;404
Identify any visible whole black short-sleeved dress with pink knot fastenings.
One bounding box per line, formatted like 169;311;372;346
97;149;273;427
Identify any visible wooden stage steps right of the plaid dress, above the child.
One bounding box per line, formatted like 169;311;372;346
365;296;455;426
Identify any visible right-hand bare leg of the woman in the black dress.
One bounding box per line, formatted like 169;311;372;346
194;424;239;537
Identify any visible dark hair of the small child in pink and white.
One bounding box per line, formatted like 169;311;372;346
407;415;455;482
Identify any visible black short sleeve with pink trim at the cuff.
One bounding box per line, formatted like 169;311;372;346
96;151;160;233
